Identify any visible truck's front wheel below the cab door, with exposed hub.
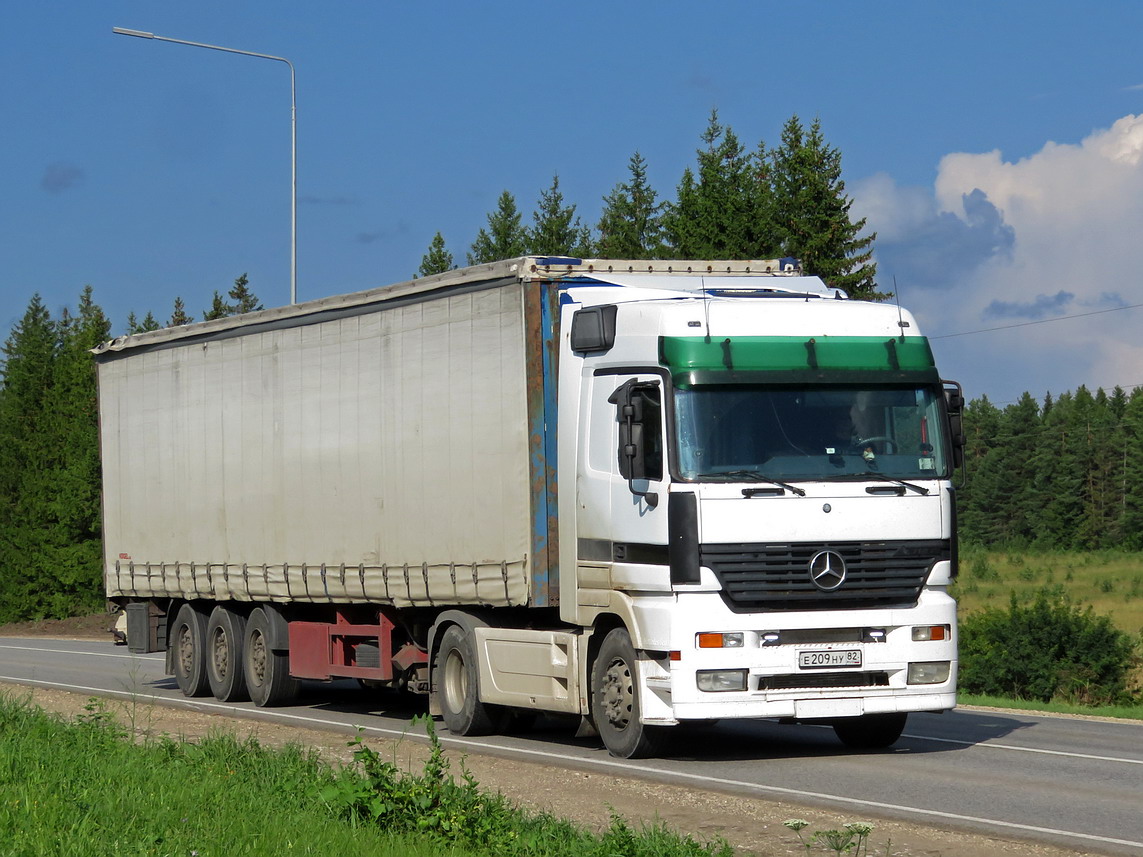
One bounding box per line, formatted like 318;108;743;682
591;627;665;759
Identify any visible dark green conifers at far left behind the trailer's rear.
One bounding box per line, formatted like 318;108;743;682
0;274;262;623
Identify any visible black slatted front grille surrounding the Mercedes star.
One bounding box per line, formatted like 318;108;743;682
700;539;950;611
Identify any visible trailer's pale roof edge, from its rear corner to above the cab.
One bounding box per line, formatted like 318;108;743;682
91;256;845;358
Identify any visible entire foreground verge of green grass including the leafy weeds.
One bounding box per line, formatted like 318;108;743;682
0;694;749;857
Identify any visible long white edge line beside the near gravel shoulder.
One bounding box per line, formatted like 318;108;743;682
0;675;1143;849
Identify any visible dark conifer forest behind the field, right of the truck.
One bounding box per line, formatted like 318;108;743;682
957;386;1143;551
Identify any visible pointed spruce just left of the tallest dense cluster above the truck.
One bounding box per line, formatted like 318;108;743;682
596;152;666;259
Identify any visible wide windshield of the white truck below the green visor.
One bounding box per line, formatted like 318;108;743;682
674;384;948;482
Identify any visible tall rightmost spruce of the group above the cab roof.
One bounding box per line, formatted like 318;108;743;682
769;115;889;301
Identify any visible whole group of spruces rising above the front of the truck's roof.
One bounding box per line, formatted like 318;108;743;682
417;111;887;301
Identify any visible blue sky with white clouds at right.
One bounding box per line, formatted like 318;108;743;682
0;0;1143;402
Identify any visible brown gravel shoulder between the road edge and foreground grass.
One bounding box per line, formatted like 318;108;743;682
0;683;1089;857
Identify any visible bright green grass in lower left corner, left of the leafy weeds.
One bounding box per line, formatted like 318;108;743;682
0;696;445;857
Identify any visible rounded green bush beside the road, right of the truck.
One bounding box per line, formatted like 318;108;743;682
959;588;1135;705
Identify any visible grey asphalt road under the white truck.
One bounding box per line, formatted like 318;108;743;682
0;638;1143;855
